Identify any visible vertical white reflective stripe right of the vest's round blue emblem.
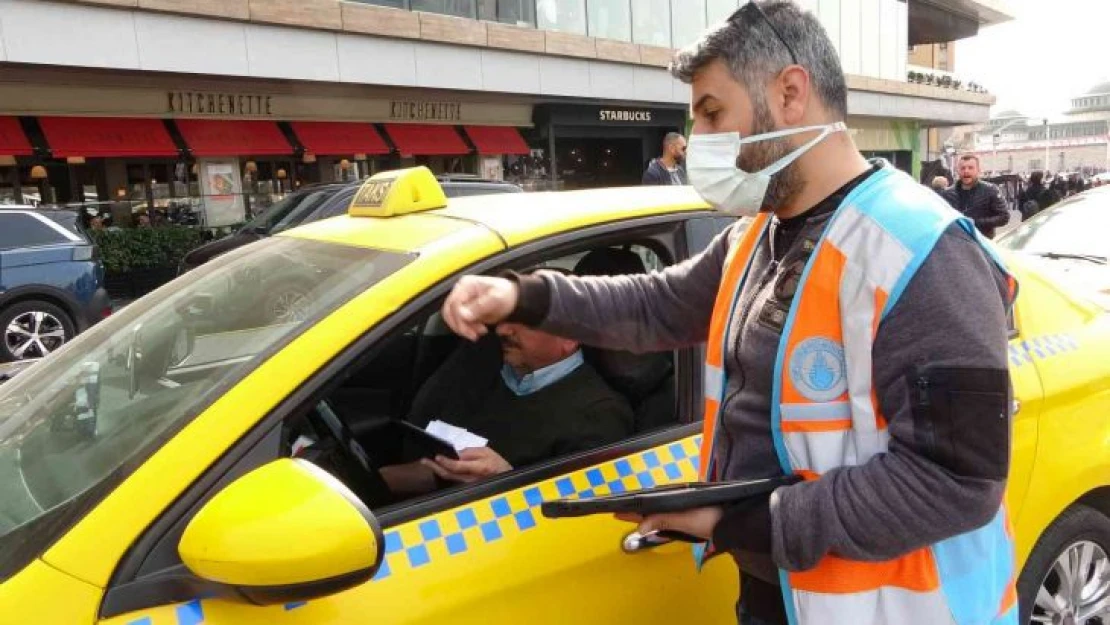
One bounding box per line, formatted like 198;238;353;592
839;261;885;462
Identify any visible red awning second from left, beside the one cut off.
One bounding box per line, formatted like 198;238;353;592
39;118;178;159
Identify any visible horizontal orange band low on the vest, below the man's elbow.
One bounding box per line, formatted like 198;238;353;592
789;548;940;594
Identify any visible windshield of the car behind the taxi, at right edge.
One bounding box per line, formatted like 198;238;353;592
998;190;1110;306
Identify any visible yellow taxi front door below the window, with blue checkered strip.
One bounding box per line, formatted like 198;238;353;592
102;435;738;625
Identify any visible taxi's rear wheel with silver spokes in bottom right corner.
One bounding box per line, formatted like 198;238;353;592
1018;505;1110;625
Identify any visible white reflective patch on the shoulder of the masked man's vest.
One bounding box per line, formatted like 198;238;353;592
826;206;914;293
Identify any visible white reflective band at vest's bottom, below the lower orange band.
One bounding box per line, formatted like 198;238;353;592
794;586;956;625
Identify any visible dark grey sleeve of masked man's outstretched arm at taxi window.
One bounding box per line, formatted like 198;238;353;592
519;226;739;353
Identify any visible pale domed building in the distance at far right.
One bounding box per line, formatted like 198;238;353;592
965;82;1110;175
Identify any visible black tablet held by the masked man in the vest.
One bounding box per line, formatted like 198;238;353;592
541;475;801;518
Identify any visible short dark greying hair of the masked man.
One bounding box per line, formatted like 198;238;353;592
670;0;848;121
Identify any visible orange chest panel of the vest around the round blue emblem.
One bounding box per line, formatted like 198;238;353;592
780;243;847;404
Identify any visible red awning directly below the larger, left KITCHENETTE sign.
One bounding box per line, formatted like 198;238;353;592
175;120;293;157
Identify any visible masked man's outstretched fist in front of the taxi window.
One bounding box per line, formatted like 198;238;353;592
443;275;519;341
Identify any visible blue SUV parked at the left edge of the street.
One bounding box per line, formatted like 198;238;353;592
0;206;112;362
